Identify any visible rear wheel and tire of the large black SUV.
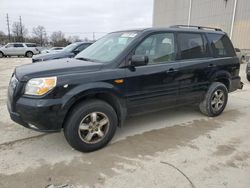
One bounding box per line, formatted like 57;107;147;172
199;82;228;117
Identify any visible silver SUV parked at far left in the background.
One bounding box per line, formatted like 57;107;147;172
0;43;40;58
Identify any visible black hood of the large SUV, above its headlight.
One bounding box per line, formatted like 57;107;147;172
15;58;102;81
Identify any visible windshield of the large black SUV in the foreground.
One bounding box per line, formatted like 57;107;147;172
75;32;140;62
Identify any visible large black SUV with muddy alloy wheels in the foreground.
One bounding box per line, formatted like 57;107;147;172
8;26;242;152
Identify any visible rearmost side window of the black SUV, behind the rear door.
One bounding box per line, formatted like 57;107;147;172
207;33;235;57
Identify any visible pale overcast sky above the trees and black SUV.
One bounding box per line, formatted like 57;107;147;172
0;0;153;38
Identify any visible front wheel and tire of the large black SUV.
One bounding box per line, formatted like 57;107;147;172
64;100;118;152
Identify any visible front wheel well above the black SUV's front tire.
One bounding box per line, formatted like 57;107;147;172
62;93;126;128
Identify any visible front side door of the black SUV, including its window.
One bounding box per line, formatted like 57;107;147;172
126;32;178;113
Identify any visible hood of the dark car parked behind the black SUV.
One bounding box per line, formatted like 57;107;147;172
32;51;74;61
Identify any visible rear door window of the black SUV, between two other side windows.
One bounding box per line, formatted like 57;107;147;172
177;33;209;59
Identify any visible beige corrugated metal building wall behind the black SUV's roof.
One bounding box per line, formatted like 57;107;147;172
153;0;250;49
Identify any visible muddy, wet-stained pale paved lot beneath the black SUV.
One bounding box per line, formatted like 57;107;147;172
0;58;250;188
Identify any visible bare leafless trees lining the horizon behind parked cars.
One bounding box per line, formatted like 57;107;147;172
0;22;88;47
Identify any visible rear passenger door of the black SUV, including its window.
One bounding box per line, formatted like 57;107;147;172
177;32;214;104
